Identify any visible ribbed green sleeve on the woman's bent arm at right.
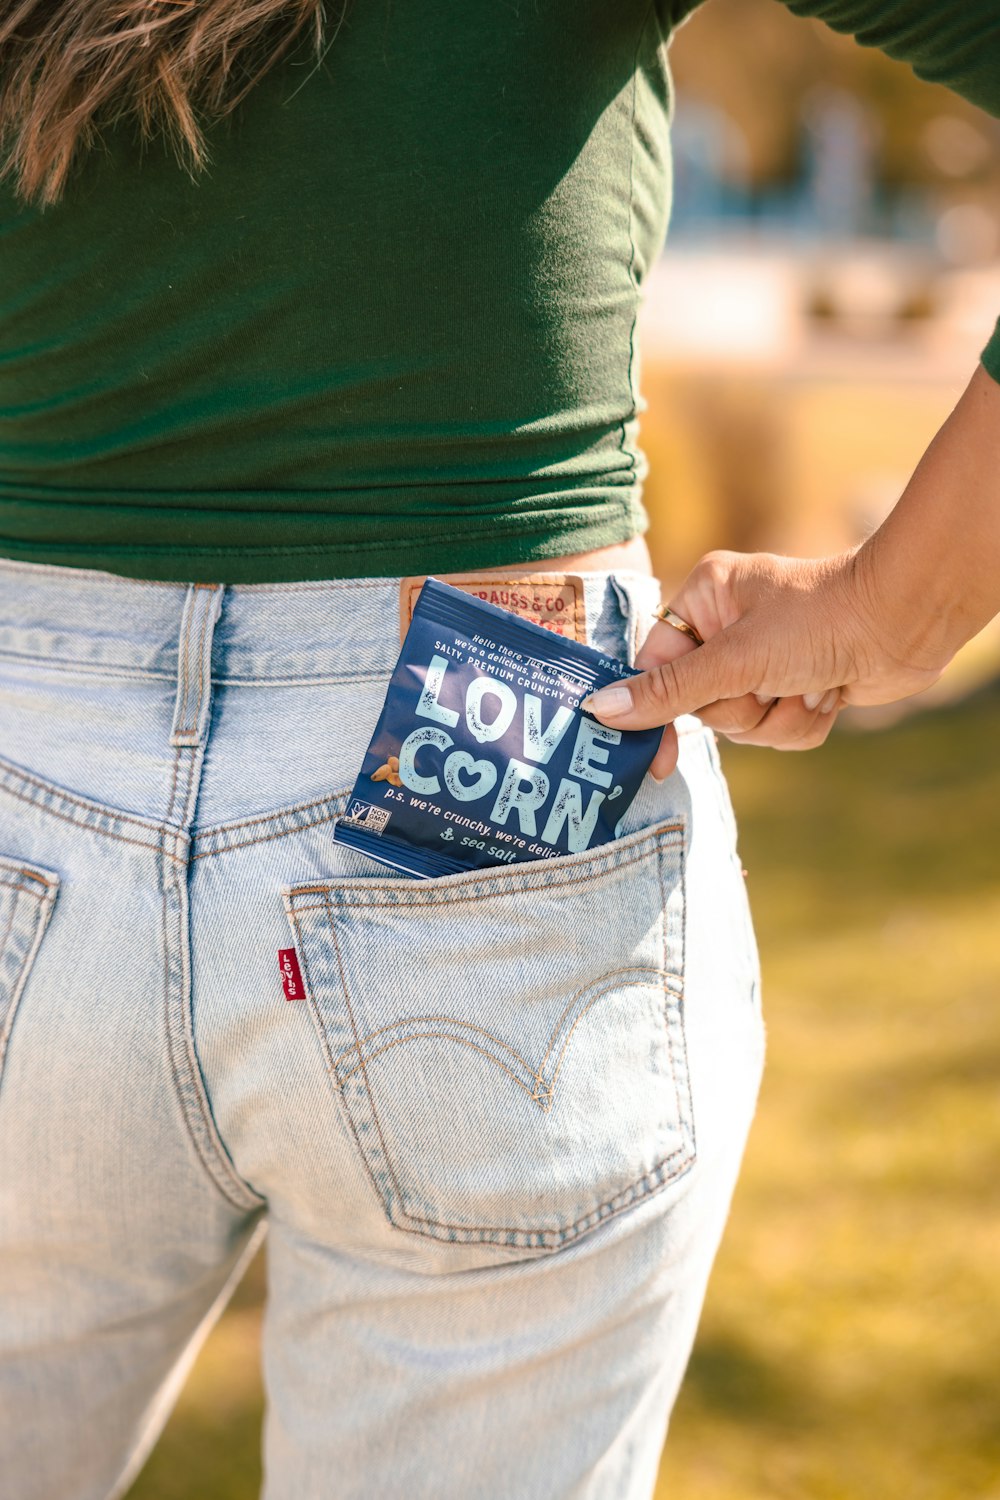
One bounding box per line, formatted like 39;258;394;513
784;0;1000;383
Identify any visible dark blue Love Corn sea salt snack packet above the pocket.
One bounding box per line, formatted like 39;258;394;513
333;578;663;879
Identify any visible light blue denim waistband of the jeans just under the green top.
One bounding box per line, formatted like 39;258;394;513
0;558;671;684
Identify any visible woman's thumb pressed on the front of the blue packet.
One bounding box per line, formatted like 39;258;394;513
582;630;757;729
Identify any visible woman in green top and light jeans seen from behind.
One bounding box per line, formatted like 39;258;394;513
0;0;1000;1500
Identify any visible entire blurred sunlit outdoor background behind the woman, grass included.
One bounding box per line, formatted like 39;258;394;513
130;0;1000;1500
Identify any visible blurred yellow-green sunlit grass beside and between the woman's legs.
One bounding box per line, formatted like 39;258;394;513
130;687;1000;1500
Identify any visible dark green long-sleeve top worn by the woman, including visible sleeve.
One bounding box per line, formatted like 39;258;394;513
0;0;1000;582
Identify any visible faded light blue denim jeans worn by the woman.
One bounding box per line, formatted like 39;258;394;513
0;560;763;1500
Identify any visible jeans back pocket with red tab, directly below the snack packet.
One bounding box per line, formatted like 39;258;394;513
282;819;694;1251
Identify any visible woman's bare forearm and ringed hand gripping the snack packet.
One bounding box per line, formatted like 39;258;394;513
586;365;1000;777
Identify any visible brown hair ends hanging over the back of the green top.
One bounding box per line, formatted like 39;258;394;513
0;0;324;206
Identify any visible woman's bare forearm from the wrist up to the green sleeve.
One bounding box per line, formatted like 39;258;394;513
855;365;1000;669
